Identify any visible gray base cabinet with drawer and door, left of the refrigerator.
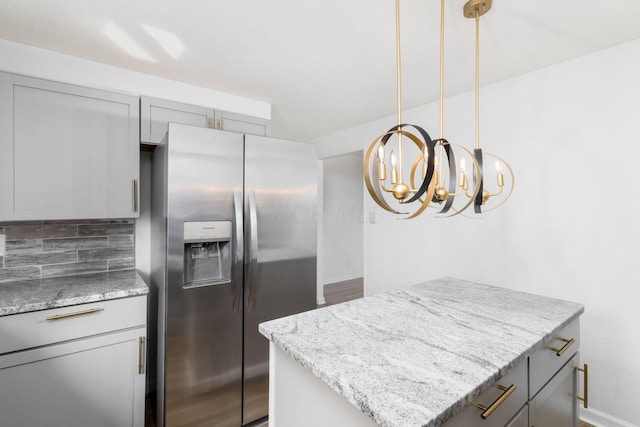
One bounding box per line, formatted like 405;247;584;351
0;296;146;427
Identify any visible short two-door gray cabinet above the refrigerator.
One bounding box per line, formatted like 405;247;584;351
140;96;271;145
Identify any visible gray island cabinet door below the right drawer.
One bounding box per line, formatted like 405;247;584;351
529;355;578;427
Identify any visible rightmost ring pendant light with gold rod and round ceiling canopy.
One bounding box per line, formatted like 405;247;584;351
461;0;515;214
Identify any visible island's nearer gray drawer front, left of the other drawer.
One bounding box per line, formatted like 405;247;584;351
443;360;527;427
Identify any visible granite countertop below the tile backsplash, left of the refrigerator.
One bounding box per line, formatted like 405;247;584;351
0;270;149;316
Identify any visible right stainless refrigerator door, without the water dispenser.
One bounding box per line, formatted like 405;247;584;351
242;135;317;424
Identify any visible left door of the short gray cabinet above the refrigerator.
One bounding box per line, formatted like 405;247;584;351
140;96;214;144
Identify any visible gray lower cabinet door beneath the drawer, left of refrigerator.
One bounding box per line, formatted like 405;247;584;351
0;328;145;427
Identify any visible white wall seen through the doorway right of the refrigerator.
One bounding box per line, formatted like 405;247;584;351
322;151;364;284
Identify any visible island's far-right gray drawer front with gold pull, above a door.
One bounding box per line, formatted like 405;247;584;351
529;318;580;399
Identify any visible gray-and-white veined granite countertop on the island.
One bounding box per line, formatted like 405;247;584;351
259;278;584;427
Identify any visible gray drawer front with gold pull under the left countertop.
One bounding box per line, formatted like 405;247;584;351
0;295;147;354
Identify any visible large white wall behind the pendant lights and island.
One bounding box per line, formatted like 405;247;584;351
316;40;640;425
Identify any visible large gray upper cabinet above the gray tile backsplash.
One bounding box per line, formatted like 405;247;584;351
0;73;140;221
